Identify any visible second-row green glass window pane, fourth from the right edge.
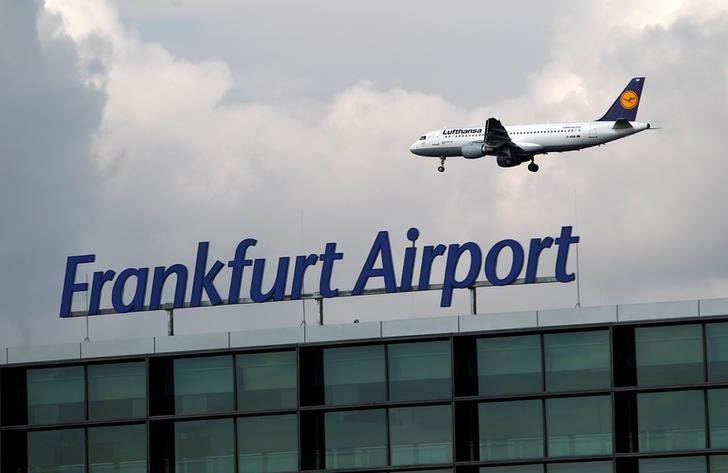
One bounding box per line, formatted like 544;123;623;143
478;400;543;461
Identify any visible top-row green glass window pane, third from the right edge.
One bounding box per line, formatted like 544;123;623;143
544;330;612;391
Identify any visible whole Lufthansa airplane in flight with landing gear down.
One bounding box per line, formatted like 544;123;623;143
410;77;650;172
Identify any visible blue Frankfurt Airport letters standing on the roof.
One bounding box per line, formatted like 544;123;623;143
60;226;579;317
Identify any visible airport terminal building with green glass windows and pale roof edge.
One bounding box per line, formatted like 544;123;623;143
0;299;728;473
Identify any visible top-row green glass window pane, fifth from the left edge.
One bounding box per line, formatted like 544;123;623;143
323;345;386;404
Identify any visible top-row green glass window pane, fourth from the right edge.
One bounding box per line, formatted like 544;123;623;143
477;335;543;396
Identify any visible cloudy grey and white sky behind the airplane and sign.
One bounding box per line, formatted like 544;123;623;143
0;0;728;346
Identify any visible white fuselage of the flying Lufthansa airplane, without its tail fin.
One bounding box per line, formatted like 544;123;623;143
410;121;650;158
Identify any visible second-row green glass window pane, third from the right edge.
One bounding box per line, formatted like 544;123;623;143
546;396;612;457
